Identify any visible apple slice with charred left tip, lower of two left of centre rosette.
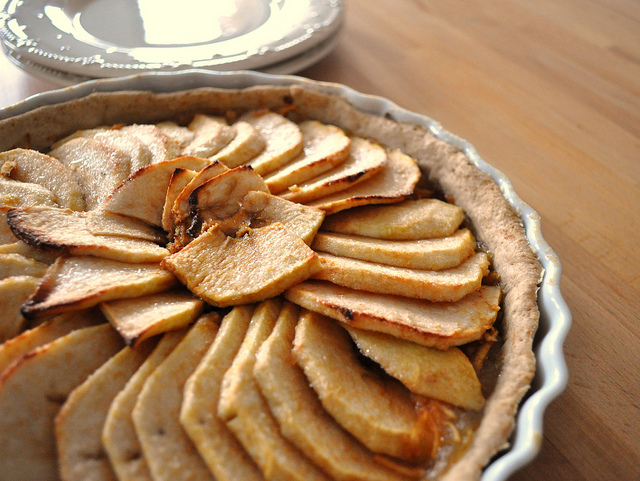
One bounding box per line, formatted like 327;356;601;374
22;256;177;319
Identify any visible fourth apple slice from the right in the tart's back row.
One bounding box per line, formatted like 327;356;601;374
240;111;303;175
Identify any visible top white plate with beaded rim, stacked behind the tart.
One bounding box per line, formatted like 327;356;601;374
0;0;344;80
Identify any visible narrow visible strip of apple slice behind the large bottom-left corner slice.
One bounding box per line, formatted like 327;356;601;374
0;309;102;376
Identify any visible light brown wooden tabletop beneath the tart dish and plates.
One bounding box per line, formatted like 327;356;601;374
0;0;640;481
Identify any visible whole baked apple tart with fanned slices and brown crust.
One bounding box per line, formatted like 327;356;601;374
0;85;541;481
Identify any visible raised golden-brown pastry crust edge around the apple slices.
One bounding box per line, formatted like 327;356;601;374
0;86;542;481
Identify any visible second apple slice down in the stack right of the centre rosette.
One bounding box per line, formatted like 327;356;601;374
312;229;476;271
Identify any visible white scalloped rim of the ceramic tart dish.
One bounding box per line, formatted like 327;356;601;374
0;70;572;481
